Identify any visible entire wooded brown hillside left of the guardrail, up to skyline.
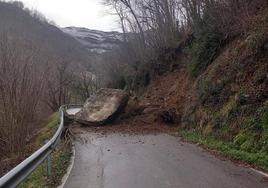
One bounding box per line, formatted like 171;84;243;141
0;1;94;174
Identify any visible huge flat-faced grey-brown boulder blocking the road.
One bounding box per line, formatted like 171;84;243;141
75;88;128;125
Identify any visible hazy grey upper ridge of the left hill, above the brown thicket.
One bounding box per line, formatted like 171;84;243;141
0;2;90;66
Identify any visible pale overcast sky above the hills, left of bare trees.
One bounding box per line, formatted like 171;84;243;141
8;0;120;31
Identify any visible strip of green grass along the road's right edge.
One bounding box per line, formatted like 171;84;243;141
179;129;268;171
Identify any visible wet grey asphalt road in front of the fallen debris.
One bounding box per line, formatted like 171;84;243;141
65;133;268;188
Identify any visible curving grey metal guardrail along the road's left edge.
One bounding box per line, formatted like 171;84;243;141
0;105;81;188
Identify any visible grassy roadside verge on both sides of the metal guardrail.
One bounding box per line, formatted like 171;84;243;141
19;113;72;188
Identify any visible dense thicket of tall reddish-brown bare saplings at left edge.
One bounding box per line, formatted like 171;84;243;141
0;35;45;158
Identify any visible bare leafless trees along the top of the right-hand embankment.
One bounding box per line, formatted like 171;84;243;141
100;0;267;94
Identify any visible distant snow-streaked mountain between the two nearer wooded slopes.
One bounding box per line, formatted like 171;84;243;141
62;27;123;54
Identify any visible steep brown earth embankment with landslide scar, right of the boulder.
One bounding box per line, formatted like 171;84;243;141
115;9;268;170
